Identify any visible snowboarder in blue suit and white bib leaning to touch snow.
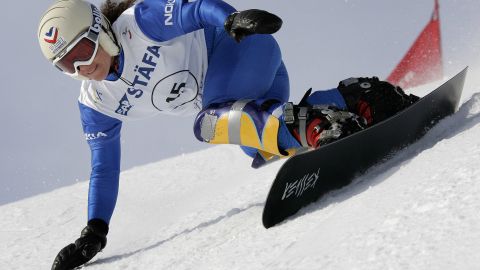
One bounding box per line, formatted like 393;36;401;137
38;0;416;270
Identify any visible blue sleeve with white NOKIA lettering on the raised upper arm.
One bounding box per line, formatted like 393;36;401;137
135;0;236;42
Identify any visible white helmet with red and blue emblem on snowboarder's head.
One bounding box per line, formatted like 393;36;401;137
38;0;120;79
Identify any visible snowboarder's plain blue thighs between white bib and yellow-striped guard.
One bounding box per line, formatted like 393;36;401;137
203;28;289;108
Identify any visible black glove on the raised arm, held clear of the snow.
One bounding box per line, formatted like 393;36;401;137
225;9;282;42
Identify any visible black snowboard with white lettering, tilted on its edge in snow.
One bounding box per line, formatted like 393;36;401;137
262;68;468;228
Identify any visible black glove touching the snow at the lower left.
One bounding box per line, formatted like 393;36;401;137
52;219;108;270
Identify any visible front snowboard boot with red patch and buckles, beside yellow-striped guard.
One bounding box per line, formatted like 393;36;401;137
284;91;367;149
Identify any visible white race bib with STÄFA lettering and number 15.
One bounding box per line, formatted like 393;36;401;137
79;8;208;120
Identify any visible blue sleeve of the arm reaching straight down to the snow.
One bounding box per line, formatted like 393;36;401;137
79;103;122;224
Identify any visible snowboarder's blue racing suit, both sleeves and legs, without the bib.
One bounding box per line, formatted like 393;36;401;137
79;0;345;223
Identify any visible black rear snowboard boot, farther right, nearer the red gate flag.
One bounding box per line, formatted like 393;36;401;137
338;77;419;126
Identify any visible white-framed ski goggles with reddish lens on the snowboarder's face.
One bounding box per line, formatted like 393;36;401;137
53;27;100;76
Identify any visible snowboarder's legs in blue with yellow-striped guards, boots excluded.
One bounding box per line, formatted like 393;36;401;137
195;30;354;159
